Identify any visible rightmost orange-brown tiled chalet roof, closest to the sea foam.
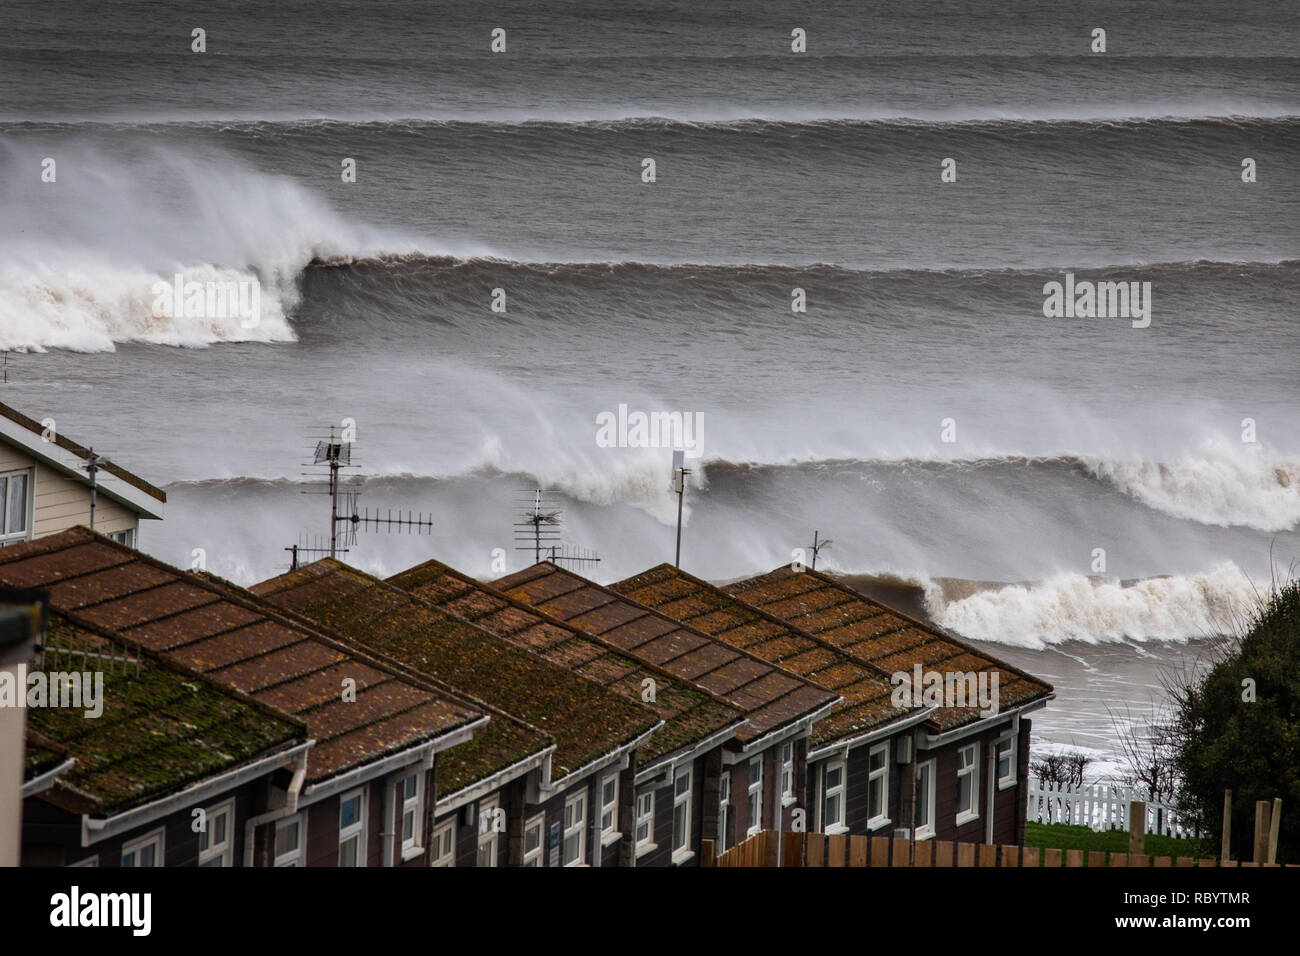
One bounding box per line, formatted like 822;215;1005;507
725;564;1052;730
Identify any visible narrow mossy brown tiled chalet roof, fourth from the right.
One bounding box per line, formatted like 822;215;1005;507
389;561;745;766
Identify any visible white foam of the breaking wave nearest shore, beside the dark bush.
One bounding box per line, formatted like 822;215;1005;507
926;562;1261;648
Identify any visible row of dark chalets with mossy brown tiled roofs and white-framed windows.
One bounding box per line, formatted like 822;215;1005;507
0;528;1052;866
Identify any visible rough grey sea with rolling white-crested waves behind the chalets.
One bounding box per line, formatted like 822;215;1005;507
0;0;1300;774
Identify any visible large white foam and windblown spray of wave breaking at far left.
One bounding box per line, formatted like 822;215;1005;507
0;146;481;351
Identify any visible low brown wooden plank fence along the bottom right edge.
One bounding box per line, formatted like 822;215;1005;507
701;830;1296;868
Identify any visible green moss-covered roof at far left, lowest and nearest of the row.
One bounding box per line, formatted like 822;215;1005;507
26;613;307;813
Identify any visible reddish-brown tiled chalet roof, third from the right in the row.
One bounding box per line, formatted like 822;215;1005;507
495;562;836;743
